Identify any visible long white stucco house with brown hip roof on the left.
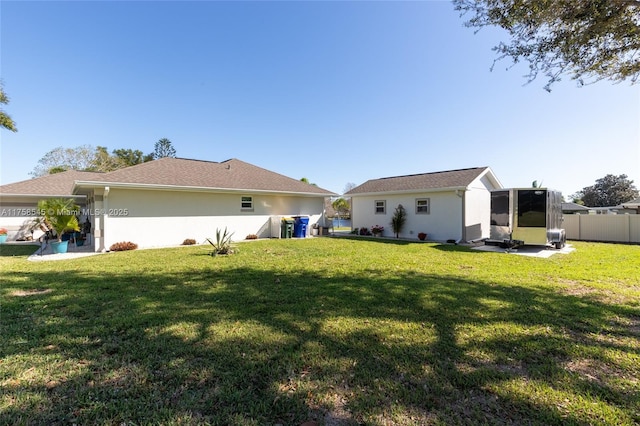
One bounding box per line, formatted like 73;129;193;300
0;158;335;251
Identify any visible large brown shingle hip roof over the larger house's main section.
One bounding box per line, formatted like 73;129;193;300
75;157;333;196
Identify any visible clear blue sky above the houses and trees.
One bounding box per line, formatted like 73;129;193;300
0;1;640;195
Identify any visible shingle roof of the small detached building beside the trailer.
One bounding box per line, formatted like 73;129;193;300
345;167;488;195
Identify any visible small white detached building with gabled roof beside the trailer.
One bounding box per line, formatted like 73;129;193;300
345;167;502;241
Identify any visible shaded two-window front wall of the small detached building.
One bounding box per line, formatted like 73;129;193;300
351;191;462;241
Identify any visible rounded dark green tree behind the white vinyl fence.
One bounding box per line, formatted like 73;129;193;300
576;174;638;207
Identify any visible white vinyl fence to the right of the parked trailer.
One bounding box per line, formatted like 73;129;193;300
564;214;640;243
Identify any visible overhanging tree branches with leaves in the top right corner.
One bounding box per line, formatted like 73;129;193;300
453;0;640;90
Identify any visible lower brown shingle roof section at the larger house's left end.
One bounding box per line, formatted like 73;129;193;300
0;170;104;195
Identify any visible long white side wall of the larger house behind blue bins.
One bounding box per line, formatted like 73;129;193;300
92;188;324;251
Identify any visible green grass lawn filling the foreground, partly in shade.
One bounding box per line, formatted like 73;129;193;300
0;238;640;425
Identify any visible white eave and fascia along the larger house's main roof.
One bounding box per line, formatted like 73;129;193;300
73;181;336;198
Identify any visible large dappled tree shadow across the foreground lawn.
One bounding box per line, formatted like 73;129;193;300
0;264;640;425
